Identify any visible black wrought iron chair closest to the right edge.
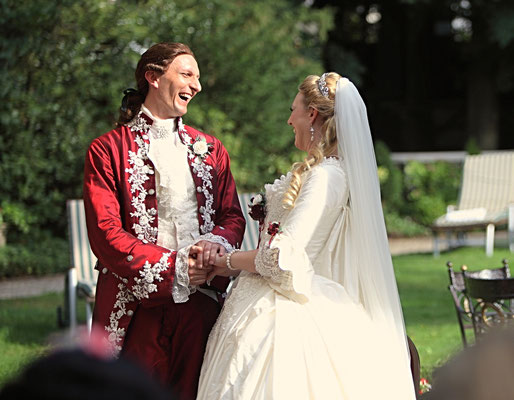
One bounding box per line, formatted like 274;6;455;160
461;260;514;339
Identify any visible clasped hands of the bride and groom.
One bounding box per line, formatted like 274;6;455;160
188;240;230;286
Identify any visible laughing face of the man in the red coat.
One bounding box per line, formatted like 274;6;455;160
152;54;202;119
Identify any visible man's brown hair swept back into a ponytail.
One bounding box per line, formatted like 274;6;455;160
117;42;195;125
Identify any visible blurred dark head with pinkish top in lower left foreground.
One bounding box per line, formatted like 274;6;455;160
0;328;173;400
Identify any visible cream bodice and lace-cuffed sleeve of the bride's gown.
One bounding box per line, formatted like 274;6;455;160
250;158;348;297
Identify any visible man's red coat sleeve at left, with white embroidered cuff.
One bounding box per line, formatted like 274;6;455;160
84;134;176;305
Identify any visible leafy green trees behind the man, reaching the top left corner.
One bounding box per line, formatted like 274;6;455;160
0;0;330;240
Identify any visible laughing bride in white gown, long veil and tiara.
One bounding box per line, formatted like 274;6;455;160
194;73;415;400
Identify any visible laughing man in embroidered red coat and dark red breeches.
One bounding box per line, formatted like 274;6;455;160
84;43;245;399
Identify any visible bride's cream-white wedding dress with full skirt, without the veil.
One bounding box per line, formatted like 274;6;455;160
197;158;414;400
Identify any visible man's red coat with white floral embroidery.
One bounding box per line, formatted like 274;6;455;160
84;113;245;352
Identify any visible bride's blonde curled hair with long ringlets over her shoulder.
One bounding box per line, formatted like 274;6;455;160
282;72;341;208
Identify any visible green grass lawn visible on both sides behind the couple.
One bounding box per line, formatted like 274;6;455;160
0;248;510;387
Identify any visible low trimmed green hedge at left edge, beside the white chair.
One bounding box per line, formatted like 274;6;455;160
0;238;69;279
